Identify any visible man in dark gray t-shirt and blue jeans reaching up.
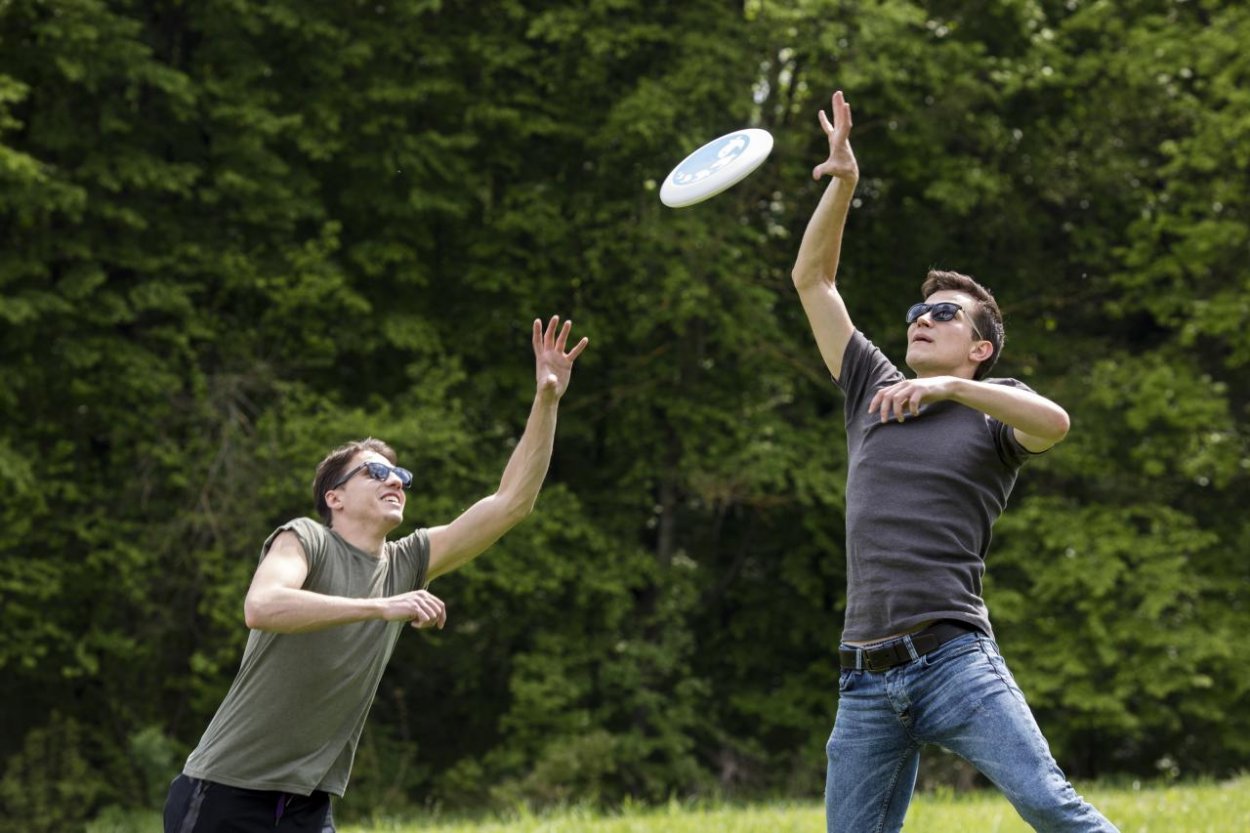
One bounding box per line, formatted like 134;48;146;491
793;91;1116;833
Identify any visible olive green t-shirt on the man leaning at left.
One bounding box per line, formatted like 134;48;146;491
183;518;430;797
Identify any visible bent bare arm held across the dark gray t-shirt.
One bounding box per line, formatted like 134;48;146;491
868;376;1070;453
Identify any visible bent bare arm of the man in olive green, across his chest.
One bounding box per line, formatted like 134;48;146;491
244;530;446;633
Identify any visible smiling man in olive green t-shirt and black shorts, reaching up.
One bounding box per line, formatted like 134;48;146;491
165;316;588;833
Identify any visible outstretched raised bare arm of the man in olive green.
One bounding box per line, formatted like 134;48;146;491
429;316;589;579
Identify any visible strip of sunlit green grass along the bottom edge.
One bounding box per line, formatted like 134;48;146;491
88;775;1250;833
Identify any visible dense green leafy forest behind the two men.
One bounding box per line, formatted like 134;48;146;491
0;0;1250;830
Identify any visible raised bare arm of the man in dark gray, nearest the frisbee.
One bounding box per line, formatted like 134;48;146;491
791;91;859;379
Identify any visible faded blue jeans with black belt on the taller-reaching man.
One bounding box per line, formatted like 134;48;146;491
825;633;1116;833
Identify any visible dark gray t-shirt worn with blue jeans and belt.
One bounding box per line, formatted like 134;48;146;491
838;330;1030;642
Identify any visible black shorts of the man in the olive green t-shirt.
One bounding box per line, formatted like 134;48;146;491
165;775;335;833
